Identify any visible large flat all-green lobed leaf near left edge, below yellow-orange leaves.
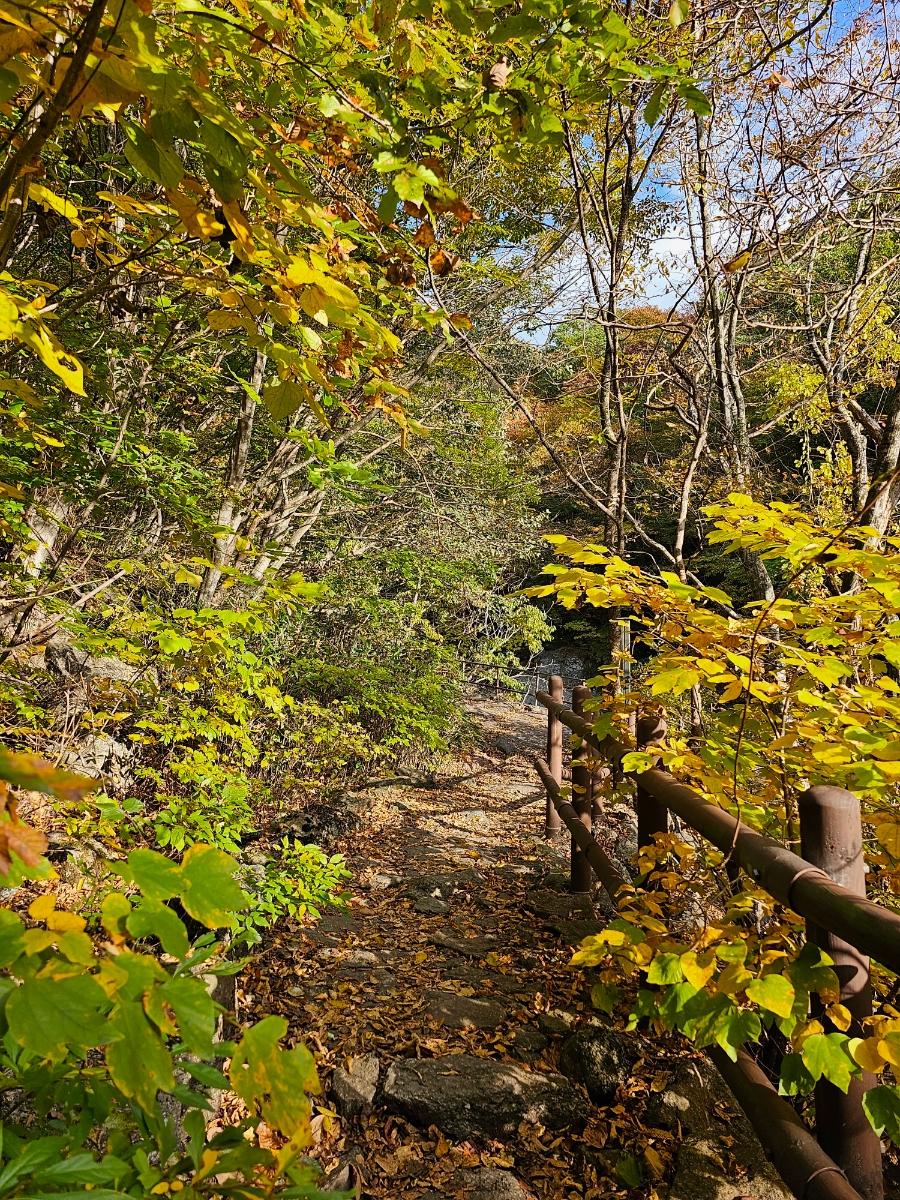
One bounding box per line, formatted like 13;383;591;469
6;974;115;1062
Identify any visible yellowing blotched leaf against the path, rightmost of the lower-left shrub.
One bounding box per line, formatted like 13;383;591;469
228;1016;319;1136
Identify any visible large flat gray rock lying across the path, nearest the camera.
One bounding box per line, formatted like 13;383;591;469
380;1055;590;1141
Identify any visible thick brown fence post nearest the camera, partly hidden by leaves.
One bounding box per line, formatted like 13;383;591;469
799;786;884;1200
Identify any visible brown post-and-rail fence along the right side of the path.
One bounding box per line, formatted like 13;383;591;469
536;676;900;1200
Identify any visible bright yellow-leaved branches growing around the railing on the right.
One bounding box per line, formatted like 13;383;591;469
542;494;900;1130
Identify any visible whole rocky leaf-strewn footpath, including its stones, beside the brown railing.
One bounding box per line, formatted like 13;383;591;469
232;700;790;1200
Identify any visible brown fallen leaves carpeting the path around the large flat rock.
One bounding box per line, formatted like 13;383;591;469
229;702;742;1200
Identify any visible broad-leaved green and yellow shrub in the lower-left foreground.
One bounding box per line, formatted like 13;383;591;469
0;751;336;1200
